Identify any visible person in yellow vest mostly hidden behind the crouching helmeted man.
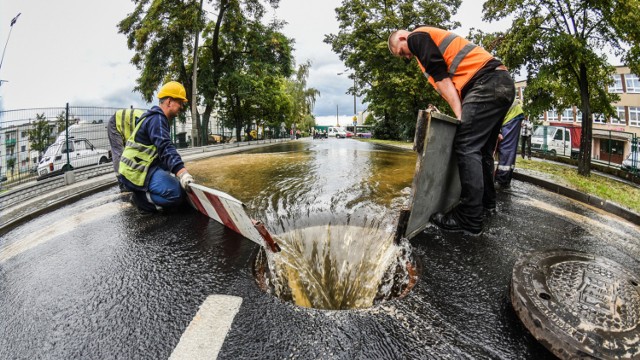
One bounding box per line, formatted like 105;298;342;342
107;109;144;190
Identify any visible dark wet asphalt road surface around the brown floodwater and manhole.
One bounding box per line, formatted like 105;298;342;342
0;139;640;359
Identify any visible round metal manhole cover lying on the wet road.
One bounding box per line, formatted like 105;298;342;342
511;250;640;359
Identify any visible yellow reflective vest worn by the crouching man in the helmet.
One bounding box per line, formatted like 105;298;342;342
118;118;158;187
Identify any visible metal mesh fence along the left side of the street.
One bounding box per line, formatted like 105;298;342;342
0;105;288;189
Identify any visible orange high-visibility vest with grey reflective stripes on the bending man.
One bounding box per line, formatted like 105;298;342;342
411;26;493;96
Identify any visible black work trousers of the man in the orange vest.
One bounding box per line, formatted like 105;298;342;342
452;70;515;229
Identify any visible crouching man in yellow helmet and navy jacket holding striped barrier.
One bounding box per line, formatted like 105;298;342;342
118;81;193;212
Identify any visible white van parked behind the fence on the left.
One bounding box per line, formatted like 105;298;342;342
38;138;111;180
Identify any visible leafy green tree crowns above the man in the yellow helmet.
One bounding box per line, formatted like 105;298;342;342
118;0;293;144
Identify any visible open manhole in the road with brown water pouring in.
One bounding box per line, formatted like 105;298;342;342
253;225;418;310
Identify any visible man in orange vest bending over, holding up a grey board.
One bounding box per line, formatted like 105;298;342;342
389;26;515;234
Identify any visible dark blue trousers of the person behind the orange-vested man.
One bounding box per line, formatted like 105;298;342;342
496;114;524;186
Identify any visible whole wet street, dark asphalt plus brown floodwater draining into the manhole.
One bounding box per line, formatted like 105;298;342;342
0;139;640;360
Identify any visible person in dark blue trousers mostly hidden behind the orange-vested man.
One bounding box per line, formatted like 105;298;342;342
495;99;524;189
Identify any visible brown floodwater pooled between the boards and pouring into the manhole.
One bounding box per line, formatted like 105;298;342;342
188;139;416;310
